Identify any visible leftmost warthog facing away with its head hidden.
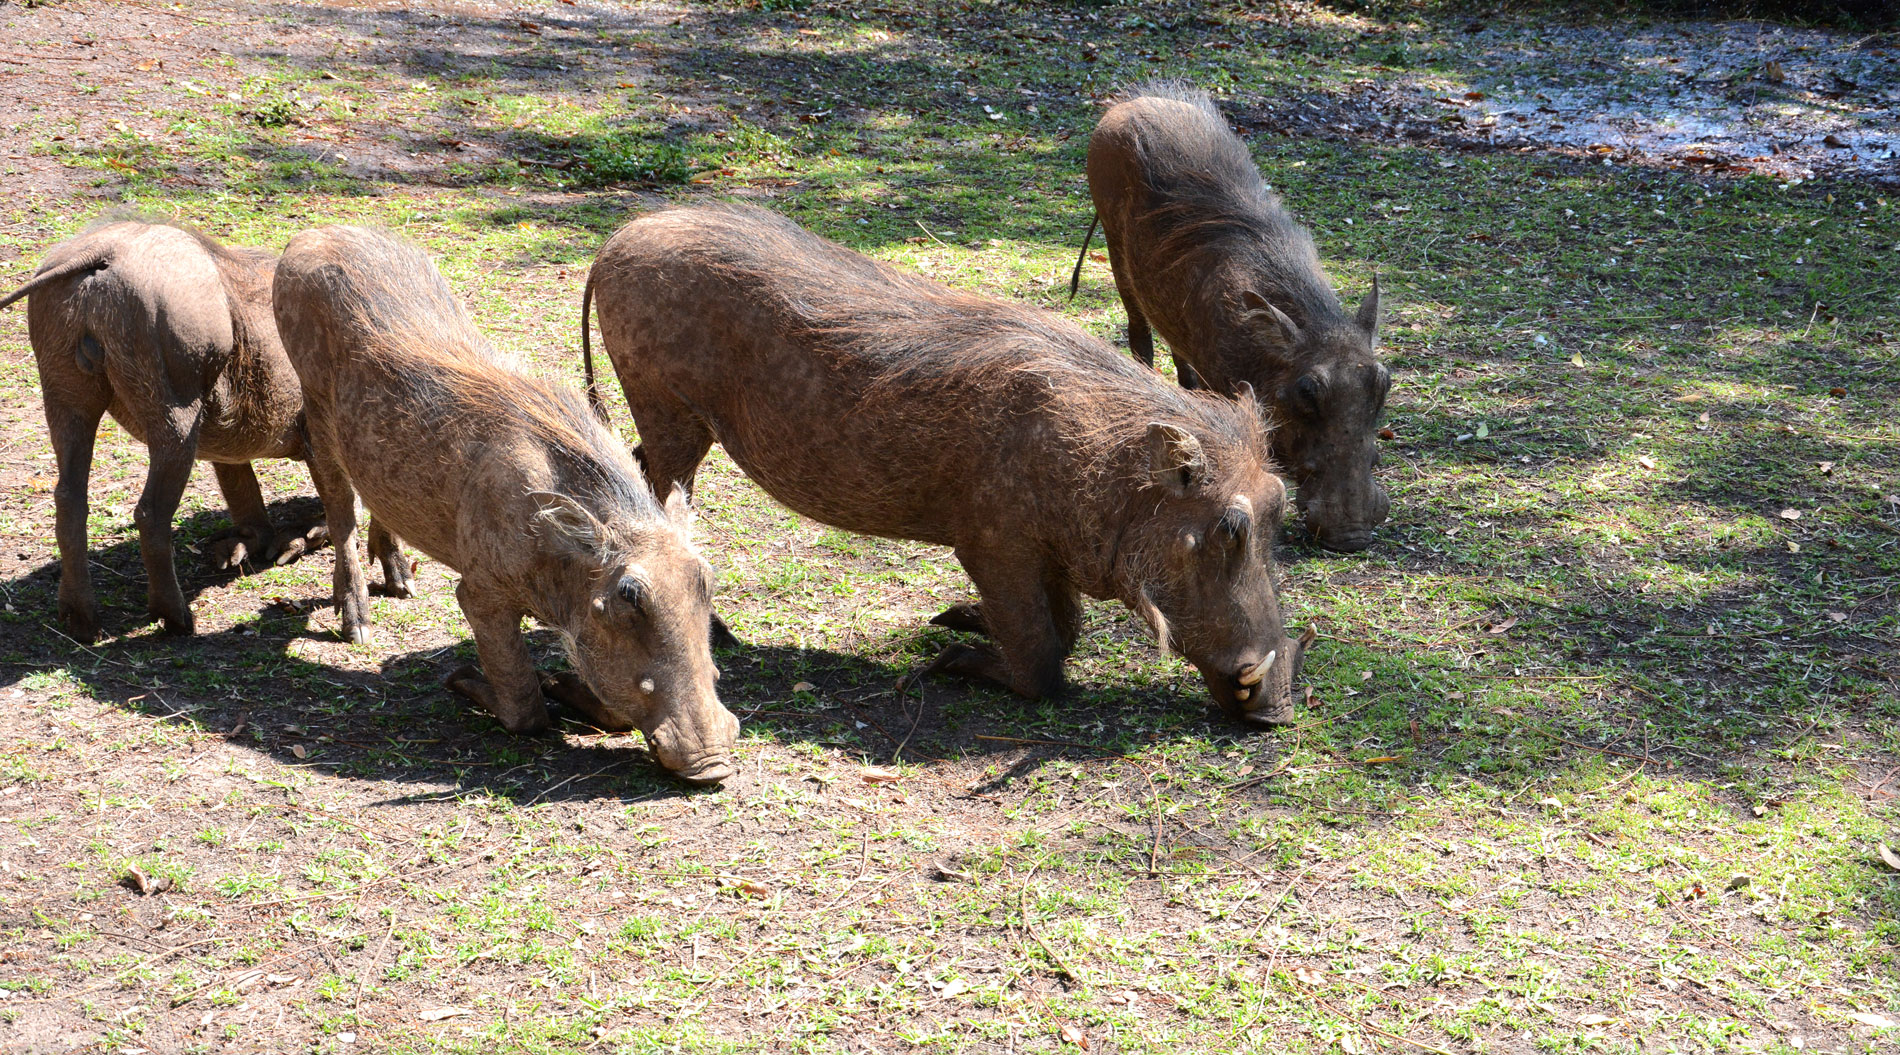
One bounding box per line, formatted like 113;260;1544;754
0;221;359;643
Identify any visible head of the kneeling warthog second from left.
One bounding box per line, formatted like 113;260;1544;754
540;489;739;783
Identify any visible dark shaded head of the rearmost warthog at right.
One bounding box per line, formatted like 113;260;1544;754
1243;281;1393;551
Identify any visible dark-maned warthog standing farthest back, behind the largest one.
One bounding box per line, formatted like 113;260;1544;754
1072;86;1391;551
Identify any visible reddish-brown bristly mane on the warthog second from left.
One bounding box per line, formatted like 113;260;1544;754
325;232;665;523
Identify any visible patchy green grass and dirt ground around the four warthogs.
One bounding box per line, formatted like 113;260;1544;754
0;2;1900;1053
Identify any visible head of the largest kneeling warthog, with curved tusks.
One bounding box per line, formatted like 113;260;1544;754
1134;422;1311;724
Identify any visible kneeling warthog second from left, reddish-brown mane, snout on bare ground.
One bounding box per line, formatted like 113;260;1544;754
274;226;739;781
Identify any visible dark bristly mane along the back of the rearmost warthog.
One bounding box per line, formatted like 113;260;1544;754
1113;82;1345;327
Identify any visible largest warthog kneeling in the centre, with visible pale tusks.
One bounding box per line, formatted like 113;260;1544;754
581;205;1303;722
